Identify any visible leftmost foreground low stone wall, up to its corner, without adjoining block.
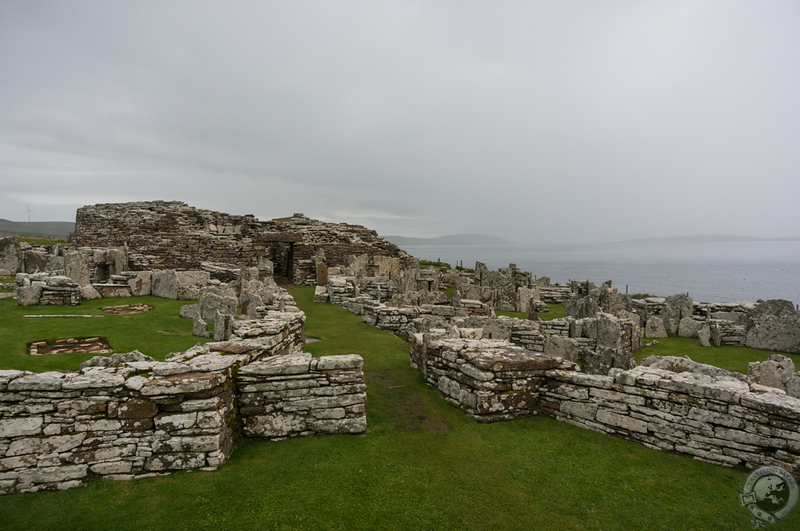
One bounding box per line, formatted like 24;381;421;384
0;355;237;494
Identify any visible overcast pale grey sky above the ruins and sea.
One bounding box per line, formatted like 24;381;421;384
0;0;800;242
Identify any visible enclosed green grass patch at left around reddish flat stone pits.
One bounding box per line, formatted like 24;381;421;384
0;297;205;372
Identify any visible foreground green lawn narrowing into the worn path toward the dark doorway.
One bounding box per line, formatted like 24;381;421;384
0;287;800;531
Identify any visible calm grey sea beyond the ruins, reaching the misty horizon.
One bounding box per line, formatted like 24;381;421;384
403;241;800;304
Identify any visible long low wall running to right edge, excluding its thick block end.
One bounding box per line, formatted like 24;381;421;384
539;366;800;476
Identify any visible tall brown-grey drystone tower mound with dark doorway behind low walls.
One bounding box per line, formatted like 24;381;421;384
72;201;413;284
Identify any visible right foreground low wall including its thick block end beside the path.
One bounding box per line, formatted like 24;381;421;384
411;334;800;475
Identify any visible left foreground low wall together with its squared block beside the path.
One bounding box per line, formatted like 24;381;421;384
0;312;366;494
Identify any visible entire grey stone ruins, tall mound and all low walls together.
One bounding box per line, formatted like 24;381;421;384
0;202;800;492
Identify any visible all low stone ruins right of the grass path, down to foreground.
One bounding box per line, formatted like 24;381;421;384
315;256;800;475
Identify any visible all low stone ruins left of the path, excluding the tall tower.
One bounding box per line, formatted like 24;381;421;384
0;219;372;494
